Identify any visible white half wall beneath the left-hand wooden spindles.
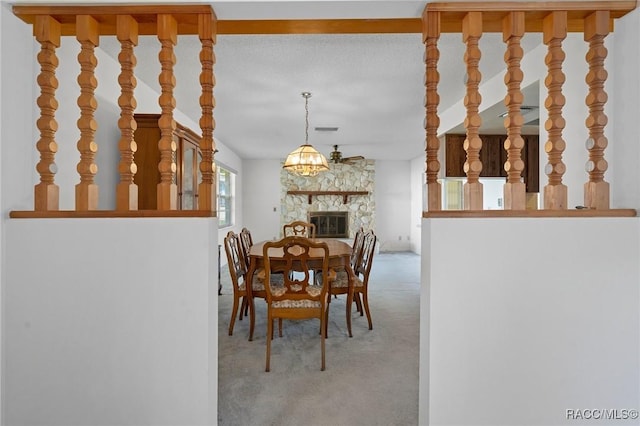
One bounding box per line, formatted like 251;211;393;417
3;218;218;425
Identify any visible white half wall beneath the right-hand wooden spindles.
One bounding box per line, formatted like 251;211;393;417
420;218;640;425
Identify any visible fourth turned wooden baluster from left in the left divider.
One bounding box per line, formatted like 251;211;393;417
157;14;178;210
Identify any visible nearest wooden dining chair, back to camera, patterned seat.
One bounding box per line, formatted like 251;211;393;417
263;236;329;371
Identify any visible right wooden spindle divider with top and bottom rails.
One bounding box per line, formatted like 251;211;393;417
422;1;636;217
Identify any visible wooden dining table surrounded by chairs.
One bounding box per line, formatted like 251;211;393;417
245;238;355;341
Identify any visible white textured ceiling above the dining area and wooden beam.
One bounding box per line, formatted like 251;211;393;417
100;0;540;160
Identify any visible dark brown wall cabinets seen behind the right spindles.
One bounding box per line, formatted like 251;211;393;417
445;134;540;192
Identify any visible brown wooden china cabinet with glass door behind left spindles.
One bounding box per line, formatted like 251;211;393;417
134;114;202;210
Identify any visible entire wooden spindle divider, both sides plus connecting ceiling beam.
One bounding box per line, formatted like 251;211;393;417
7;0;636;217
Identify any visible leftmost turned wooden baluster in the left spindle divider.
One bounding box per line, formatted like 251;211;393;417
33;15;61;211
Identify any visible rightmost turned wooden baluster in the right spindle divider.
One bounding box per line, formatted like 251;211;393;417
584;11;609;209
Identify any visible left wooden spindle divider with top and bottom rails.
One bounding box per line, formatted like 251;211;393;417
13;4;217;217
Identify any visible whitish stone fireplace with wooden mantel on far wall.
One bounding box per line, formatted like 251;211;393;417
280;160;375;238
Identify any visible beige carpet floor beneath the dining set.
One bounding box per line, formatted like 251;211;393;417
218;253;420;426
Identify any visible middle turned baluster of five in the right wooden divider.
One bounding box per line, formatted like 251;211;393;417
502;12;527;210
